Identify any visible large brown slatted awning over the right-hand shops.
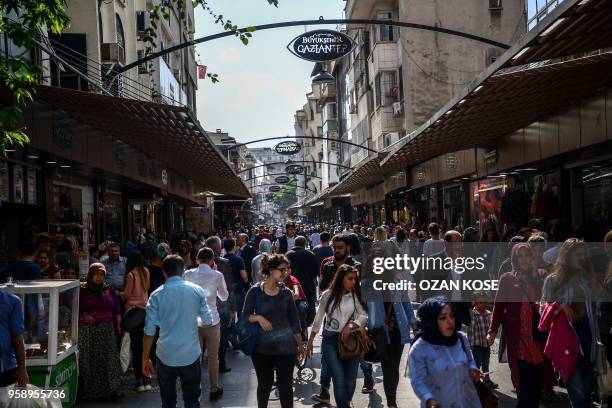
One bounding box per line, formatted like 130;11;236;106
381;0;612;174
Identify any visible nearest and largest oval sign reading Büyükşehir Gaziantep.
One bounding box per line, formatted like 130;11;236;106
287;30;355;62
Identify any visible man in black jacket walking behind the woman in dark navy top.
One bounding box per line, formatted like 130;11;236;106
286;237;319;329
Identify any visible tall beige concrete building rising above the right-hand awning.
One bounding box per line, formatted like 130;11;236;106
316;0;527;220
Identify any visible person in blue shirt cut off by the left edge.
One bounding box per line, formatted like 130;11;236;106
0;290;29;406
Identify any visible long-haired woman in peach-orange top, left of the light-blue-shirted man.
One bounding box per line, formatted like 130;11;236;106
121;250;151;392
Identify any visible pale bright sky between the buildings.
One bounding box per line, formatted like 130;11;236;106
195;0;345;147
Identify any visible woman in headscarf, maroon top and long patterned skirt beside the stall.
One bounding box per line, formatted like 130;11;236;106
79;263;123;399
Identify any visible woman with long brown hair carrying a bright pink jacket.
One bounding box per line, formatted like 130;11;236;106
542;238;599;408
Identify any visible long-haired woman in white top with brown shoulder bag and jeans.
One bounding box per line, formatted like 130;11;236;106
306;264;368;408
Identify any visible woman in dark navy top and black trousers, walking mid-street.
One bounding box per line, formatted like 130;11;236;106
242;254;303;408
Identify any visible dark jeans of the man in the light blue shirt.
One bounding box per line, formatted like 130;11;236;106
157;357;202;408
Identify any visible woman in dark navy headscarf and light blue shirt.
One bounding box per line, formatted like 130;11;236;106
407;296;483;408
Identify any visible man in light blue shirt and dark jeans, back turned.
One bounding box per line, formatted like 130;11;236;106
142;255;213;408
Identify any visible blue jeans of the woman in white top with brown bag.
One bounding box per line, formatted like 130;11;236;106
321;330;359;408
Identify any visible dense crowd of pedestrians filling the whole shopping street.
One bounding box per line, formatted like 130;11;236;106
0;215;612;408
